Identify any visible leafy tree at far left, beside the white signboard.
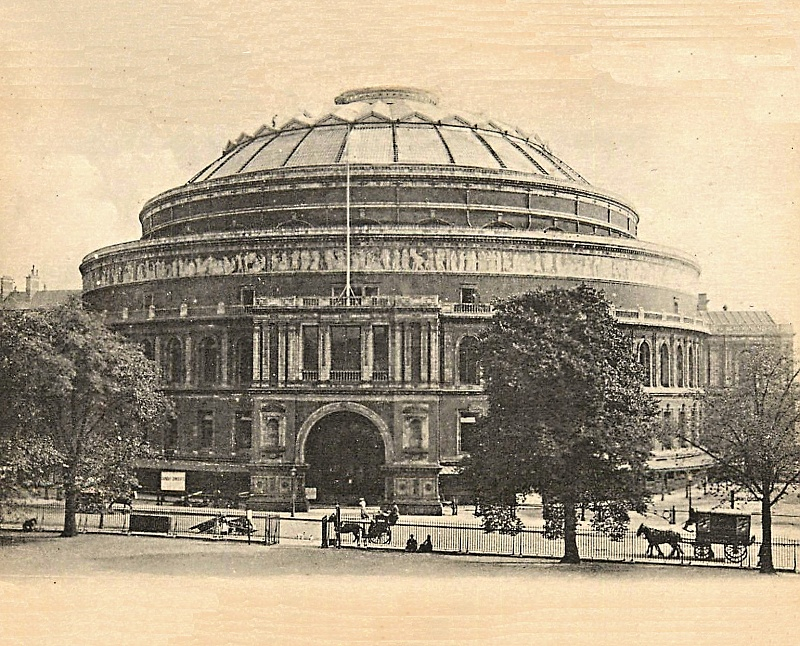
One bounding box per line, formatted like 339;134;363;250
0;302;171;536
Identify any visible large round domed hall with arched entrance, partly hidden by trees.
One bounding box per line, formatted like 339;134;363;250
81;88;708;514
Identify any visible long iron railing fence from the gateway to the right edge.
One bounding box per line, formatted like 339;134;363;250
322;514;800;572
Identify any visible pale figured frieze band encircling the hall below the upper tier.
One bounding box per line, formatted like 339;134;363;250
83;239;697;291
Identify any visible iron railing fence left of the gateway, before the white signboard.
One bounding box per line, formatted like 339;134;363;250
0;501;280;545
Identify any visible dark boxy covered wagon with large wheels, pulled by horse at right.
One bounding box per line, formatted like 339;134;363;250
683;509;755;563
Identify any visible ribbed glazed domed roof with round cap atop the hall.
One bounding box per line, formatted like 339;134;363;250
190;88;586;184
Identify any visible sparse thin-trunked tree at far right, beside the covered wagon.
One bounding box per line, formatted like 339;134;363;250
686;345;800;574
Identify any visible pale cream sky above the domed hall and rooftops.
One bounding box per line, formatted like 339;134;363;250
0;0;800;331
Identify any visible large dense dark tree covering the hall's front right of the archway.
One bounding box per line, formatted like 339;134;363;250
464;286;655;563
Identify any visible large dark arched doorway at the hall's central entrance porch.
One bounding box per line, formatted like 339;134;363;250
304;412;385;505
